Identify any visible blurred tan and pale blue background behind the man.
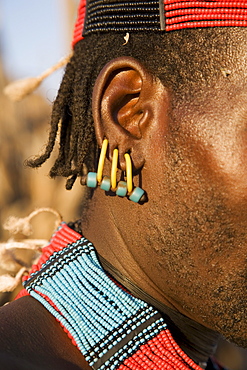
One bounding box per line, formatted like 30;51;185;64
0;0;247;370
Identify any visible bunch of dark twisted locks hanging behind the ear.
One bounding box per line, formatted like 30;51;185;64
27;49;95;189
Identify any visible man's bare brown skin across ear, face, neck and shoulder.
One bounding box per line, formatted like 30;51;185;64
0;35;247;369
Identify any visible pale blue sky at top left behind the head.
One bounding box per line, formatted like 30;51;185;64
0;0;78;100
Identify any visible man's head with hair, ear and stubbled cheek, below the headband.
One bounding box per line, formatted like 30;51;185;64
29;1;247;346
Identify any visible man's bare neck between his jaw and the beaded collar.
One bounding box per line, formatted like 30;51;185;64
81;192;219;368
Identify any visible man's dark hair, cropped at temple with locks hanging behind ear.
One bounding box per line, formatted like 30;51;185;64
27;28;245;189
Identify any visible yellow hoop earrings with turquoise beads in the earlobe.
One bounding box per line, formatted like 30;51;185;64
86;139;145;203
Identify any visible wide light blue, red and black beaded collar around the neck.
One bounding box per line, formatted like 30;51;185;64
18;223;202;370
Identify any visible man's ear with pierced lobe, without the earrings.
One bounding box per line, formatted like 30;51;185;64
92;57;167;170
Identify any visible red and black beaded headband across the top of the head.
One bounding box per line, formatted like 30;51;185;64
72;0;247;45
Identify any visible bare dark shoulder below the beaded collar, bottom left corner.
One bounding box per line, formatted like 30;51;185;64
0;297;91;370
